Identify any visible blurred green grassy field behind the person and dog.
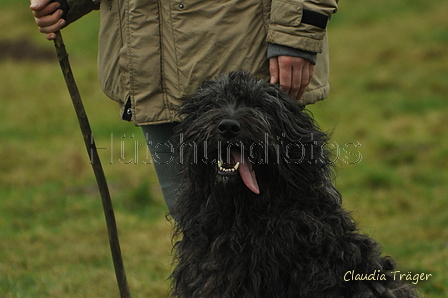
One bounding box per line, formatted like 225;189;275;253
0;0;448;298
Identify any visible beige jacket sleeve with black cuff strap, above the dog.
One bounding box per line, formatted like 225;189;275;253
267;0;339;53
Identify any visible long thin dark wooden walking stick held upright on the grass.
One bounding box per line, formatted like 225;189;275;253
54;31;131;298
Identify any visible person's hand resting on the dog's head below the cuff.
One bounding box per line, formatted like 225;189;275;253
269;56;314;100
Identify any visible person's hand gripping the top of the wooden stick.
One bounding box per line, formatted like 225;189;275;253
30;0;65;40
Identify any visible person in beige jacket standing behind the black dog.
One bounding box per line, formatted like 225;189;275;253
30;0;339;212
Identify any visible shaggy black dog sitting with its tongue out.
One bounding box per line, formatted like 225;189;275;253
171;72;419;298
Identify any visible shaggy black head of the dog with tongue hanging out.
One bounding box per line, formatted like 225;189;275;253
176;72;329;194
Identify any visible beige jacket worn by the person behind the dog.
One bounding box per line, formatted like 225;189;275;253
67;0;338;125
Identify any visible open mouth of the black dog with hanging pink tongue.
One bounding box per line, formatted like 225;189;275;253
218;149;260;194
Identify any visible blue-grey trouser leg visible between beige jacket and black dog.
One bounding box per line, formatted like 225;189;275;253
142;123;179;211
